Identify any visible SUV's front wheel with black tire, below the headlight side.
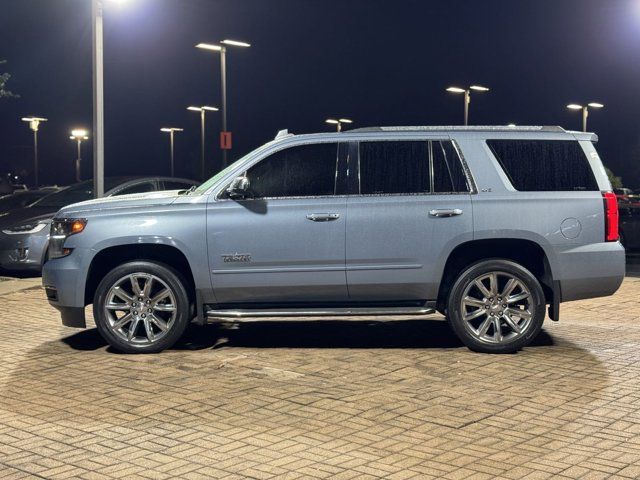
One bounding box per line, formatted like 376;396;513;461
93;261;191;353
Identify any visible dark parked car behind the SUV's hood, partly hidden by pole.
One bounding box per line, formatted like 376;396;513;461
0;177;197;272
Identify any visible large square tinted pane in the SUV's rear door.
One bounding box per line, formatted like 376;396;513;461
360;141;430;195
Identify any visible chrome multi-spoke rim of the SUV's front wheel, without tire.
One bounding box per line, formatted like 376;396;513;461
104;272;177;345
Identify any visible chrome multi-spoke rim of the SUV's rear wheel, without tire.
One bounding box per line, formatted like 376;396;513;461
460;272;535;344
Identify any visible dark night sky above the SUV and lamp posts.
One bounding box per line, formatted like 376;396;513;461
0;0;640;188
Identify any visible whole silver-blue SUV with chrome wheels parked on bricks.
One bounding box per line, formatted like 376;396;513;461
43;127;625;353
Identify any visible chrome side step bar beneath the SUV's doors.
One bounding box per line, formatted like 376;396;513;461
205;307;436;319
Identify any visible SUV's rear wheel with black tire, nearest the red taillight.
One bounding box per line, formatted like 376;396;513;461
447;259;546;353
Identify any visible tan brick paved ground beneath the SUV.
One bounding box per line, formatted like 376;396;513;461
0;279;640;479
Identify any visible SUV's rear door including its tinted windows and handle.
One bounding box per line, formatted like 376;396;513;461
346;137;473;303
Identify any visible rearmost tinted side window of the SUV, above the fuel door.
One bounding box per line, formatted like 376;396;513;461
487;140;598;192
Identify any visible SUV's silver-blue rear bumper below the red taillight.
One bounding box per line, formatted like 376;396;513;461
553;242;625;302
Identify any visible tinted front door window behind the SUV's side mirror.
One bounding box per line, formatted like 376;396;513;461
247;143;338;198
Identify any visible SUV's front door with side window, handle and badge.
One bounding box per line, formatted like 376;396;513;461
207;143;347;305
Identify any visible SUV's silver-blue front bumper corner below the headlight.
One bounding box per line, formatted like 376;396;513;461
42;249;87;328
